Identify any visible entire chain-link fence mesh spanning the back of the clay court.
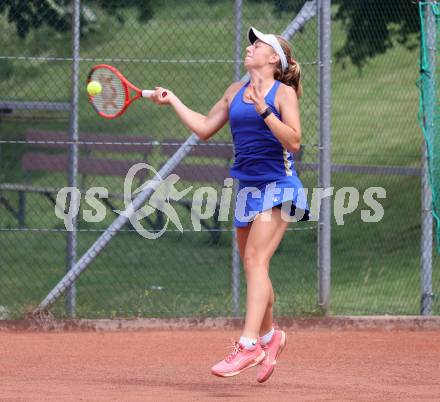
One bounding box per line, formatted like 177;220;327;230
0;0;440;317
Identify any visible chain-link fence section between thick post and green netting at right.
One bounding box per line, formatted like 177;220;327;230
332;2;440;314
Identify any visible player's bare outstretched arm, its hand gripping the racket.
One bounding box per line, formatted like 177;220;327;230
150;84;236;140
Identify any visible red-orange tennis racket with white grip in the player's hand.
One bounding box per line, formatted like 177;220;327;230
87;64;167;119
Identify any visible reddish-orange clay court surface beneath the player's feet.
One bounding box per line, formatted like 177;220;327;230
0;329;440;402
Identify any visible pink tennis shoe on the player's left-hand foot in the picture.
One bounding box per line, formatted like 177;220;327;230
211;342;265;377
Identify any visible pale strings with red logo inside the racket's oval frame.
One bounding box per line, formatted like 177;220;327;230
90;67;126;116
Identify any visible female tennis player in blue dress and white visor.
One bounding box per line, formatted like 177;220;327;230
151;27;309;382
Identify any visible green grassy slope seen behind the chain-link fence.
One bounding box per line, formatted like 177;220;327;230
0;2;440;317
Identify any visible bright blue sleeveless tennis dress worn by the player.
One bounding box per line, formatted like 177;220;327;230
229;81;310;227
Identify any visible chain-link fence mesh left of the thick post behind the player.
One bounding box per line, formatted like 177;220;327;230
0;1;317;316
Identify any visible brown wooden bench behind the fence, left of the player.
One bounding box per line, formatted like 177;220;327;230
0;130;233;242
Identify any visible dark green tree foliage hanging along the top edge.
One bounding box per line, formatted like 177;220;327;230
0;0;419;67
